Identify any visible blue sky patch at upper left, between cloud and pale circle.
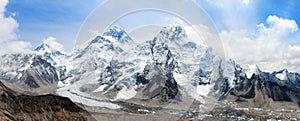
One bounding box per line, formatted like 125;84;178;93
5;0;102;50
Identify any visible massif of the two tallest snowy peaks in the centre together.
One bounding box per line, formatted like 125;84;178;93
57;26;218;108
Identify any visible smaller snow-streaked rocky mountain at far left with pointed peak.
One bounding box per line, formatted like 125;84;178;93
0;40;66;94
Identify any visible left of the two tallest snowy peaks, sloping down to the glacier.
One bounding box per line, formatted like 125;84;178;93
57;28;130;107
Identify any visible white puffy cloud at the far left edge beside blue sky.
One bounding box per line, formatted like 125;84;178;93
0;0;31;55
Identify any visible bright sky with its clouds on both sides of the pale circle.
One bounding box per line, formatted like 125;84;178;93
0;0;300;72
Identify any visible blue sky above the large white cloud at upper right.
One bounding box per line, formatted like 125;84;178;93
197;0;300;29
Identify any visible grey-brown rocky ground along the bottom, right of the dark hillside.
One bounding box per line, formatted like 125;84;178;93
82;101;300;121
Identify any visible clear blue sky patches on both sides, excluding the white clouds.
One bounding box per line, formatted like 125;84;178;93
5;0;300;50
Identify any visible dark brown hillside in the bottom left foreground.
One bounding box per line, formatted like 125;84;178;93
0;82;93;121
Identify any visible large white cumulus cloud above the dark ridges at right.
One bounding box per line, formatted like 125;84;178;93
220;15;300;72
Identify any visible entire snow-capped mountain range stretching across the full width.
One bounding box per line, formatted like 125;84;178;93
0;26;300;109
